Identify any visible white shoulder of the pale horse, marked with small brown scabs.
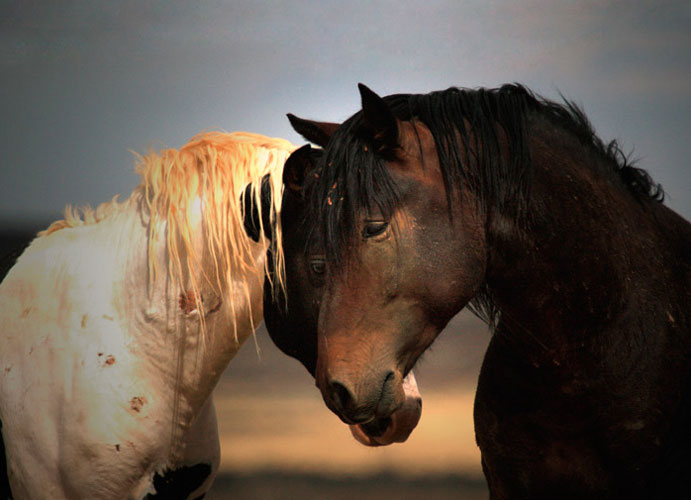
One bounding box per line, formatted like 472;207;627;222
0;222;178;498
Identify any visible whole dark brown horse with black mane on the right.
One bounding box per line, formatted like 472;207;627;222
283;84;691;499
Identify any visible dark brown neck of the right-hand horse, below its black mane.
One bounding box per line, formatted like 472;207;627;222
487;124;691;355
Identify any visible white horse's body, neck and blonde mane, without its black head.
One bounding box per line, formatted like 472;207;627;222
0;132;294;499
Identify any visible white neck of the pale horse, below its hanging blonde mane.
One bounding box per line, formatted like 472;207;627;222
117;195;265;428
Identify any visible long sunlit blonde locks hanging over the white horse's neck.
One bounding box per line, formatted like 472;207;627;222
137;132;295;298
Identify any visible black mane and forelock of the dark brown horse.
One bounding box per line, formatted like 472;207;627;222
308;84;663;265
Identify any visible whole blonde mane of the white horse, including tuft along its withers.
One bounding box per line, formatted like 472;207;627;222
39;132;295;334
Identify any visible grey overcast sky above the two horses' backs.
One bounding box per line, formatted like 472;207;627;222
0;0;691;228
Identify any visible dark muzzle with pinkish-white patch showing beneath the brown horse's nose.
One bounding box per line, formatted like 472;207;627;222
349;371;422;446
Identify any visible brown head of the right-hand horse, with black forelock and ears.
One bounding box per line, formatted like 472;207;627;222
282;86;486;434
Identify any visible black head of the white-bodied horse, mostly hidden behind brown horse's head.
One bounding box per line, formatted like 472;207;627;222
245;145;422;447
